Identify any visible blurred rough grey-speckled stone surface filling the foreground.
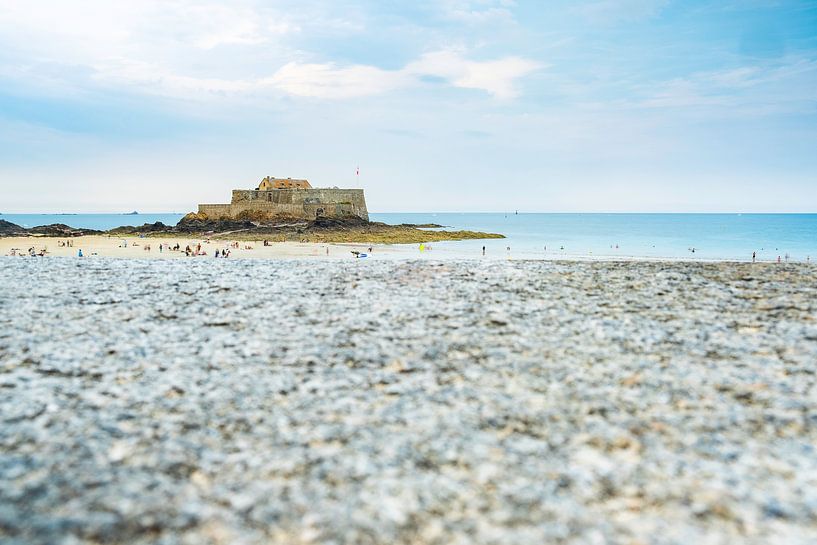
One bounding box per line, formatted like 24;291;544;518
0;258;817;545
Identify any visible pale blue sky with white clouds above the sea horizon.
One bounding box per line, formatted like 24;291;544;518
0;0;817;213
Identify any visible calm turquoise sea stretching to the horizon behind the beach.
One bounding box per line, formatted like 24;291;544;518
0;212;817;262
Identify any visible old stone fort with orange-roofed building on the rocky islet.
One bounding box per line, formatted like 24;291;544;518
199;176;369;221
